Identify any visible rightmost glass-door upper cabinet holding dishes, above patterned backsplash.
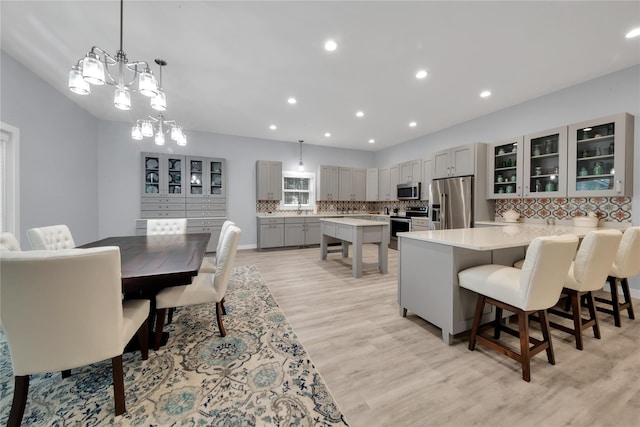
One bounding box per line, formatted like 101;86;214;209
567;113;634;197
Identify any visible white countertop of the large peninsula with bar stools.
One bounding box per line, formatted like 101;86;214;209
398;223;616;251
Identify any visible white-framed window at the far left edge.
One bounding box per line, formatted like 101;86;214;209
0;122;20;237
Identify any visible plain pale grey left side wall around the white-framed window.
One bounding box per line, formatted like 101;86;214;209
0;52;98;249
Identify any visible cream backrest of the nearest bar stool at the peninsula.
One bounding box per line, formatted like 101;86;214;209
520;234;578;310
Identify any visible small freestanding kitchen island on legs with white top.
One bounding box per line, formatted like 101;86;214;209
320;218;389;277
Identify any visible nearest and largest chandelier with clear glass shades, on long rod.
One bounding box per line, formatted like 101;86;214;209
69;0;166;111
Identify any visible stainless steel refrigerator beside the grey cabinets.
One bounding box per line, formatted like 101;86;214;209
429;176;474;230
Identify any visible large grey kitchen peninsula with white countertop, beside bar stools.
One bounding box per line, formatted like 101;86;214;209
398;223;630;344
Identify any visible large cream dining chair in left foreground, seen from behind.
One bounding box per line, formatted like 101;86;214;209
0;246;150;426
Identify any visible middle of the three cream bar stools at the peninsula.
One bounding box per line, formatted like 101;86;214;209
549;230;622;350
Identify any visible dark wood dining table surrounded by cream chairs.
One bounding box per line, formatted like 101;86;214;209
78;233;211;344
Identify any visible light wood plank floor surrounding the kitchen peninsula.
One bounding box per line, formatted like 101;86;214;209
236;245;640;427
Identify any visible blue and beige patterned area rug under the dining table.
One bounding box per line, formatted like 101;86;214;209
0;266;348;427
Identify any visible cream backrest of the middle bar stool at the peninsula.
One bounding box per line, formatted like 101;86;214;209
565;230;622;292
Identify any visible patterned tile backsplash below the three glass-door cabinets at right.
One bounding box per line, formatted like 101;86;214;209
496;197;631;222
